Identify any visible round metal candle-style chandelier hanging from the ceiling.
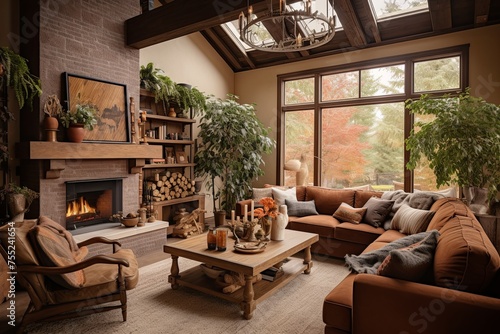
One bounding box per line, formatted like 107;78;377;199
238;0;335;52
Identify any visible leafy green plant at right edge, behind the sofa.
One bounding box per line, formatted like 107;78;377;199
406;89;500;213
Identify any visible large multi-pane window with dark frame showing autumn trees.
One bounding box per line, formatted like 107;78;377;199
279;46;468;191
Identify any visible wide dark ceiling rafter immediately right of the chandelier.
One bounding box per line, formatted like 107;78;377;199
329;0;367;47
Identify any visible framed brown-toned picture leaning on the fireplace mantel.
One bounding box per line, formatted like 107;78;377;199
63;72;131;143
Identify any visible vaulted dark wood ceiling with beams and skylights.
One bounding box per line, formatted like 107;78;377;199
126;0;500;72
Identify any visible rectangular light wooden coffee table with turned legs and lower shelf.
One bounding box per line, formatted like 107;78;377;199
163;230;319;319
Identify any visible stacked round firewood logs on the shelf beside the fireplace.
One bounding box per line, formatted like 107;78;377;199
148;171;195;202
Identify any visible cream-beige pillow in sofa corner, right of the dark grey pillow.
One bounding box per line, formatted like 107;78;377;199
391;204;434;234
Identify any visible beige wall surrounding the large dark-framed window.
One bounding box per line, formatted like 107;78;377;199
235;25;500;186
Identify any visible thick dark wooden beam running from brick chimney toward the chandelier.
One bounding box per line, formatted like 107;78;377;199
125;0;267;49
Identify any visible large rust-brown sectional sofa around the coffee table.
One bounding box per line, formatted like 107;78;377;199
238;186;500;333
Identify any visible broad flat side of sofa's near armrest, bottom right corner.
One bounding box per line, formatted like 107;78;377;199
352;274;500;333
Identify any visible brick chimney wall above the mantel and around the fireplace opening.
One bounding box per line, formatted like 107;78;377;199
35;0;140;227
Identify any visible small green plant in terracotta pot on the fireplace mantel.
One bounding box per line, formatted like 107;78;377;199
60;99;99;143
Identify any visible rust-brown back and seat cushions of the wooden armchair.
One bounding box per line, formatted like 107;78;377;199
29;225;85;289
